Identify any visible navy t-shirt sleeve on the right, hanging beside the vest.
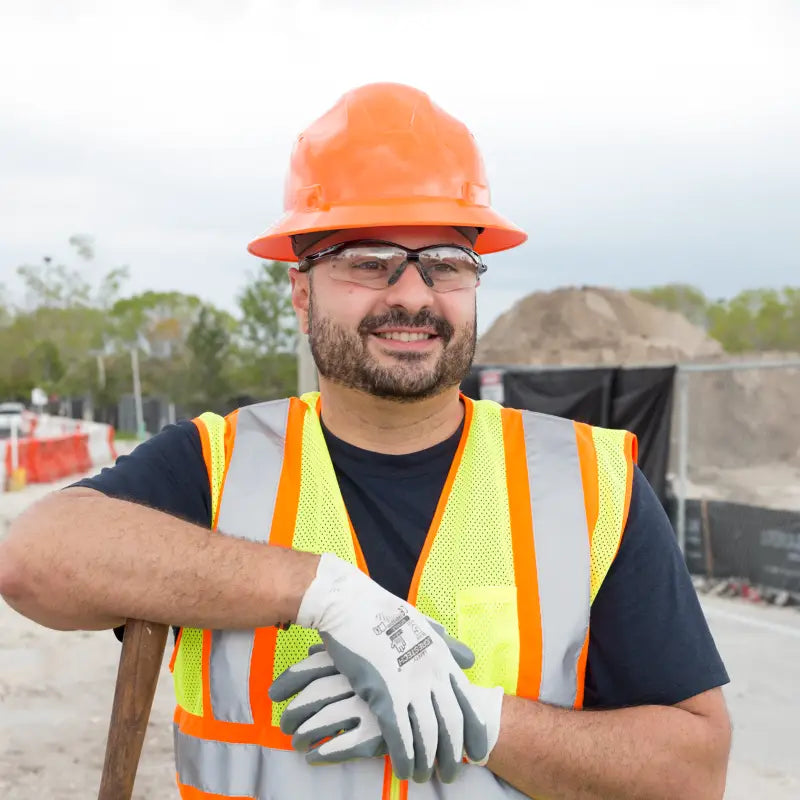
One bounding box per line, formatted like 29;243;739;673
584;467;729;708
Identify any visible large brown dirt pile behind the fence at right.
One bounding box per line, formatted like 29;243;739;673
475;287;800;477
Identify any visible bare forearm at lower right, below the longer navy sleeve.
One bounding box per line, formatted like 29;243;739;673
488;690;730;800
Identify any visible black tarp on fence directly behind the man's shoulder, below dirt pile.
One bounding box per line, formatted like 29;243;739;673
461;366;675;503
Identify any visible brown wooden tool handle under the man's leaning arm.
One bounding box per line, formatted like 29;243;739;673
97;619;168;800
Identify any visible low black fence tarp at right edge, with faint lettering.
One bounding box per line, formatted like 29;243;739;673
669;500;800;595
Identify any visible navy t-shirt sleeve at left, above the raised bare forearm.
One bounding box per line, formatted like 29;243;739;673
72;421;211;527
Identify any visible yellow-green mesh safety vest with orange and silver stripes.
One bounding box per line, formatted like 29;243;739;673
171;393;636;800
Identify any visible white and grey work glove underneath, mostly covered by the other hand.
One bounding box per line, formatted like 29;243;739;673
272;645;503;783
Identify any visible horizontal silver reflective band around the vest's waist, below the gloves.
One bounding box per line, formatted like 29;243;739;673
173;725;525;800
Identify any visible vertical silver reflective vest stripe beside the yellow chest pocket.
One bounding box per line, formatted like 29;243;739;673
522;411;591;707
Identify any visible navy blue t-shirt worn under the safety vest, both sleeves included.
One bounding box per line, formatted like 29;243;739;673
75;422;728;708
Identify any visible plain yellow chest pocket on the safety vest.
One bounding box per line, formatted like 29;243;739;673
456;586;519;694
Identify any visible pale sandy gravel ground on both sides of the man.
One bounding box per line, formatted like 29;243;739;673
0;466;800;800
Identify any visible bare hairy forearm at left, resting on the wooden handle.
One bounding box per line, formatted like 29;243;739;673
0;488;318;630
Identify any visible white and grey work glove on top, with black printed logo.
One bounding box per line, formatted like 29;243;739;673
269;553;489;782
